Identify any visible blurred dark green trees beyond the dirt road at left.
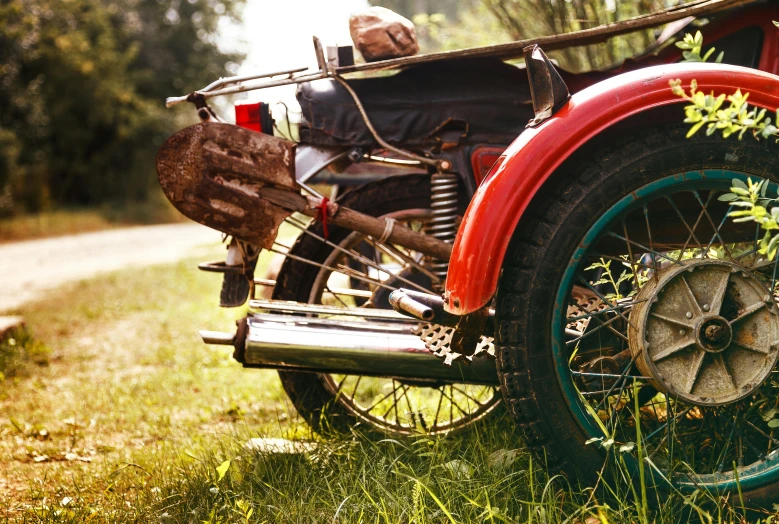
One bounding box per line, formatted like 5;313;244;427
0;0;241;214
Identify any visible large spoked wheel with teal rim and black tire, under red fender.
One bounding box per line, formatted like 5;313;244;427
497;128;779;505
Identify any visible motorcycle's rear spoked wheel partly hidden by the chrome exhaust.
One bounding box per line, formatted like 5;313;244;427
273;175;501;435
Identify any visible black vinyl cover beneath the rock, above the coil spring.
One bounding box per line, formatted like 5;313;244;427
297;58;533;147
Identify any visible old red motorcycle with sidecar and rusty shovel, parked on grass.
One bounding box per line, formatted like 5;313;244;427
158;0;779;504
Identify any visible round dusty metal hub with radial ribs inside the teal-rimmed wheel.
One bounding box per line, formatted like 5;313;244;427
628;259;779;406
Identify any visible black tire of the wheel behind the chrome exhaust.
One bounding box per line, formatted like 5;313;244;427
273;175;506;434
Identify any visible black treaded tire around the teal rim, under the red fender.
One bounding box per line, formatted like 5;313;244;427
496;126;779;505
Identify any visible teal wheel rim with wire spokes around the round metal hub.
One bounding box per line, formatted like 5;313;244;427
552;170;779;493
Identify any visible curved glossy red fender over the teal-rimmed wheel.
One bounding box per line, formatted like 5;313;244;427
445;63;779;315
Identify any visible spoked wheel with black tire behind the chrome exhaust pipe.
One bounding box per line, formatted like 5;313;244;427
274;175;501;434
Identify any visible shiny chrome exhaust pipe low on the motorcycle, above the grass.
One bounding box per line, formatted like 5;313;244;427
201;314;499;386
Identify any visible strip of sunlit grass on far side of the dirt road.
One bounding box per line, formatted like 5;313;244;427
0;195;184;243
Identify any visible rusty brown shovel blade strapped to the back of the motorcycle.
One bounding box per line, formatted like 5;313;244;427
157;122;298;248
